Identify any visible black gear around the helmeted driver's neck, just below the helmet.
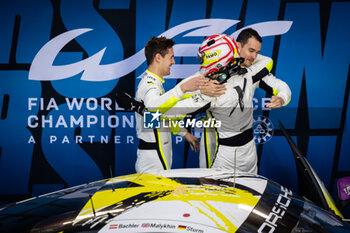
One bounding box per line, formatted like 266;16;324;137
206;57;247;84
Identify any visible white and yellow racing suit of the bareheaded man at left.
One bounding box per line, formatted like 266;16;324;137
135;70;186;173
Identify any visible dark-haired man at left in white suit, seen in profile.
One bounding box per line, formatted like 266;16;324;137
135;37;224;173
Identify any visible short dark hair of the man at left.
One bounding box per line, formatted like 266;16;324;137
145;36;175;65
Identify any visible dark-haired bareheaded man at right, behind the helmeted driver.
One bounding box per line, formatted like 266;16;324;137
199;28;291;171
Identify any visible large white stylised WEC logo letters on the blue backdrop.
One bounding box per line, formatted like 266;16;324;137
29;19;292;81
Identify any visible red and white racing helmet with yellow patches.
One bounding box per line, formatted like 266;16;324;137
198;34;239;76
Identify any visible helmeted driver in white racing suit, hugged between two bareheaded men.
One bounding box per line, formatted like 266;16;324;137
166;34;291;174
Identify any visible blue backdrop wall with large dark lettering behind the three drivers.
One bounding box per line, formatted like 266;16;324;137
0;0;350;215
